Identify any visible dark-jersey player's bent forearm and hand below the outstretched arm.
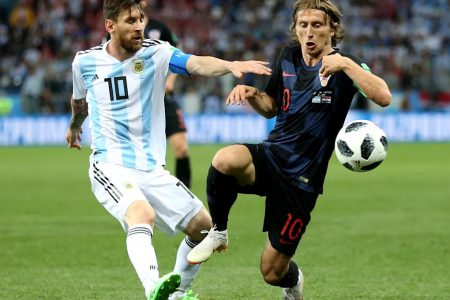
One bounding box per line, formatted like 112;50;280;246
226;85;277;119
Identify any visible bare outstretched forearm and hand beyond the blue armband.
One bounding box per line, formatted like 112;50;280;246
186;55;272;78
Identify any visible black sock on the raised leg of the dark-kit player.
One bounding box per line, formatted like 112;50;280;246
206;166;237;231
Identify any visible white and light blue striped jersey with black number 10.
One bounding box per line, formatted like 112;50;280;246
72;39;190;170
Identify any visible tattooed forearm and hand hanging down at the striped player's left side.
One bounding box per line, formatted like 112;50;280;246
66;97;88;150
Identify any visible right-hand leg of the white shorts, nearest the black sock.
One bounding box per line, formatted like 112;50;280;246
140;167;203;234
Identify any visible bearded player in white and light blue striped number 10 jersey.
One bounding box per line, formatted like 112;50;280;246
66;0;271;299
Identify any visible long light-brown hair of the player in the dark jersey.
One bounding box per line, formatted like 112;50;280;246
289;0;345;47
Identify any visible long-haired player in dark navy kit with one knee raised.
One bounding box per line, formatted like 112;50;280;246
187;0;391;300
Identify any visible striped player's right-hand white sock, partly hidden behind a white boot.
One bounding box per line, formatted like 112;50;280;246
173;237;201;290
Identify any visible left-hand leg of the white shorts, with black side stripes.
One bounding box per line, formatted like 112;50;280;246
89;162;147;229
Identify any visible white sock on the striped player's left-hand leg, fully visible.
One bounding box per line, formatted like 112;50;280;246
127;224;159;296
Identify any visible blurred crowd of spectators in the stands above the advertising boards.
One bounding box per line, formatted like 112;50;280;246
0;0;450;114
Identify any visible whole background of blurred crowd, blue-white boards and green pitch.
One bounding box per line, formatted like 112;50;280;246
0;0;450;300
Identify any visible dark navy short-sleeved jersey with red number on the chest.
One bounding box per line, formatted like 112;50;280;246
263;44;370;193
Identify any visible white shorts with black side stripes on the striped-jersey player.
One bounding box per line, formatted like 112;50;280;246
89;161;203;234
